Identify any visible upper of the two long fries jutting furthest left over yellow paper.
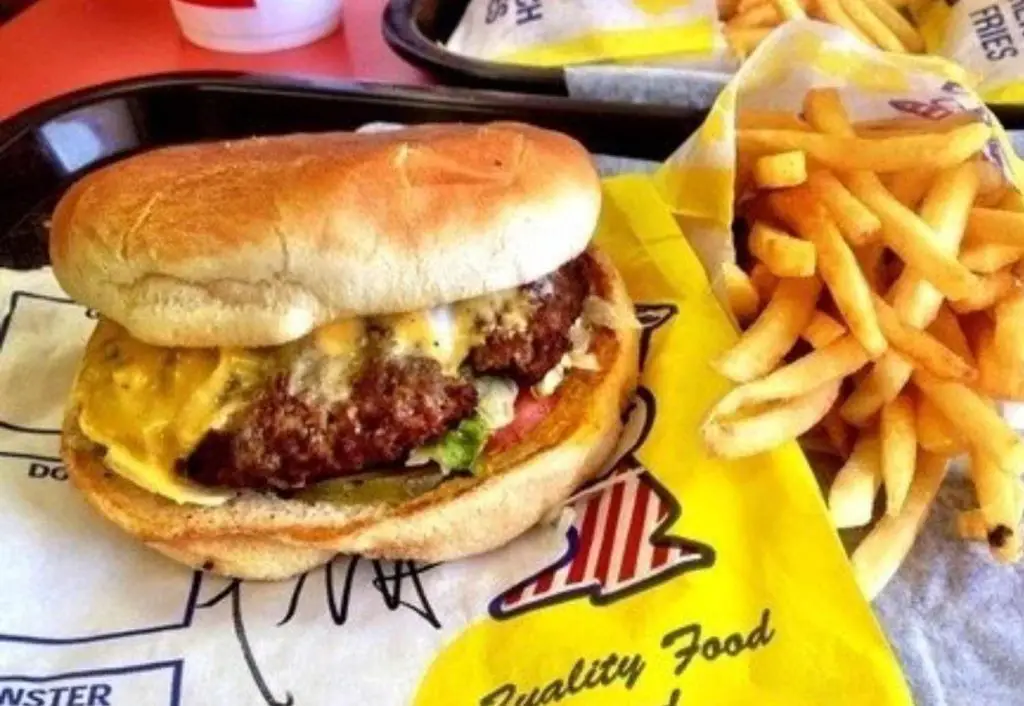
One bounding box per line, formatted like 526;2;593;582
711;335;867;418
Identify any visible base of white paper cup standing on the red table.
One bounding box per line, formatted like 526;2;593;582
171;0;342;53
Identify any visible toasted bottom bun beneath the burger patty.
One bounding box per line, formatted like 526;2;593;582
62;252;639;580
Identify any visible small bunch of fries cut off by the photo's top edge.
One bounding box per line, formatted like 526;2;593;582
718;0;925;58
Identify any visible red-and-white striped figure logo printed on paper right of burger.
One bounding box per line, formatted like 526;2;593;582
489;305;715;619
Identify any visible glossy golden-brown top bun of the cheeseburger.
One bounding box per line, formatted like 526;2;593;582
50;123;600;347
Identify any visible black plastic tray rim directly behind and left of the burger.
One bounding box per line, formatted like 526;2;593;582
0;73;703;268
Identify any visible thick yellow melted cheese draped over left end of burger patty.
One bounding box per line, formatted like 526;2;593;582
75;321;262;505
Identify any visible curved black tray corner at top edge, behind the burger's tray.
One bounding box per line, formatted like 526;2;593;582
382;0;568;95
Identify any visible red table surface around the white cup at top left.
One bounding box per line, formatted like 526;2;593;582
0;0;430;119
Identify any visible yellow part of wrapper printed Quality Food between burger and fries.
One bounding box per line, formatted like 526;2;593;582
415;176;910;706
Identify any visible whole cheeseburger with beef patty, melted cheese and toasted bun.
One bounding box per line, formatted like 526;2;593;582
50;124;639;579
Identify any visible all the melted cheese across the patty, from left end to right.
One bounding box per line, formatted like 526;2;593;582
75;282;530;505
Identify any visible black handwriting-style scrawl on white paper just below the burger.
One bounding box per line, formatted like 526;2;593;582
196;555;441;706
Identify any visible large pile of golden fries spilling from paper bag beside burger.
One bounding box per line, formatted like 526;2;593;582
701;89;1024;597
